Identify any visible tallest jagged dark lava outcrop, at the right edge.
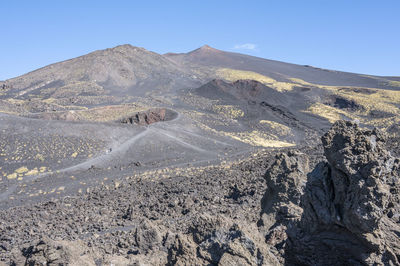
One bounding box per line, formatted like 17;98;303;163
286;121;400;265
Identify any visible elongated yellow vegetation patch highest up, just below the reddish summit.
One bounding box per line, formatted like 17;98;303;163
216;68;296;91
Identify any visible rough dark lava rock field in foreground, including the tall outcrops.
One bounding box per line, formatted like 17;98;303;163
0;121;400;265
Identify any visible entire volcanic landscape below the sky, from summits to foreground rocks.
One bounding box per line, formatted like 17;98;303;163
0;45;400;265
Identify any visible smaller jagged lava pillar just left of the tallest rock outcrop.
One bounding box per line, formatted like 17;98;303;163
257;151;309;264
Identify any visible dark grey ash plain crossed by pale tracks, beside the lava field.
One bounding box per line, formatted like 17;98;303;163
0;110;252;209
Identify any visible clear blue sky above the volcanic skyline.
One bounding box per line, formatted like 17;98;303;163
0;0;400;80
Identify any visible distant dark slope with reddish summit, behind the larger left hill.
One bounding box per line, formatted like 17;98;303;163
165;45;398;89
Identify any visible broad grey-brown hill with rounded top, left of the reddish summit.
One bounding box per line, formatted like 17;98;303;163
0;45;206;102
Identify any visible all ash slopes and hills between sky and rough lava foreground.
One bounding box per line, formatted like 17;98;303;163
0;45;400;211
